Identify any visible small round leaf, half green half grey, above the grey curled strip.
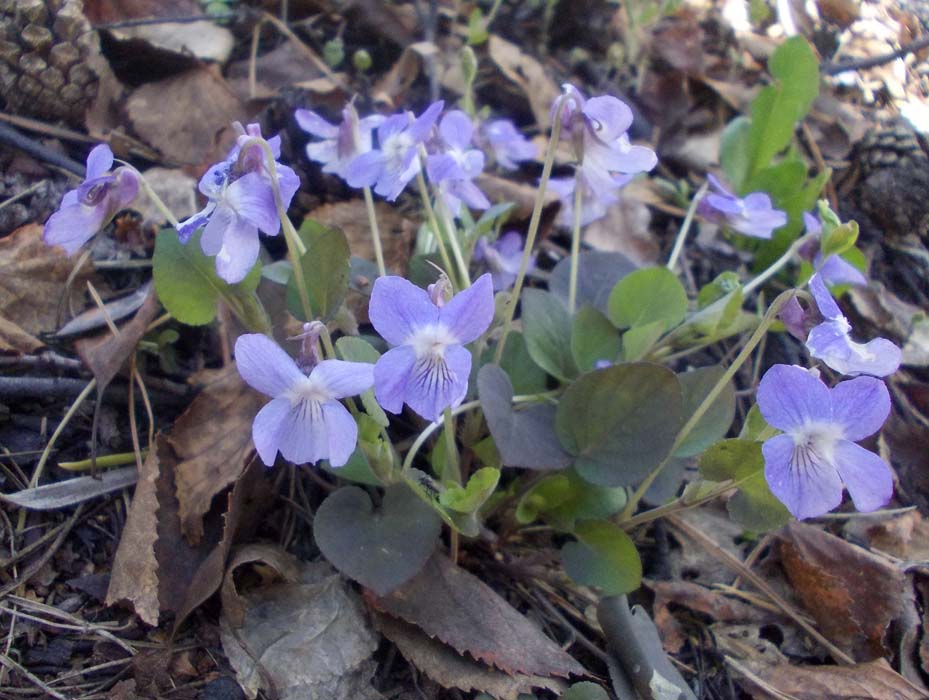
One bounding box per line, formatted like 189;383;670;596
561;520;642;595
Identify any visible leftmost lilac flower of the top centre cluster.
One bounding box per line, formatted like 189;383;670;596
294;102;384;180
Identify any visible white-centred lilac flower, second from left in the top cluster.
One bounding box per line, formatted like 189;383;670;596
345;100;445;202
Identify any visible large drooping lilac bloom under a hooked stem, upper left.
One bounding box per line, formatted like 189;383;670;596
177;124;300;284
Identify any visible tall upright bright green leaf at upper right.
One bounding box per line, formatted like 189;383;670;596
748;36;819;178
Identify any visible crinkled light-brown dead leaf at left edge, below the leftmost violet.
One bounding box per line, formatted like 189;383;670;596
0;224;90;352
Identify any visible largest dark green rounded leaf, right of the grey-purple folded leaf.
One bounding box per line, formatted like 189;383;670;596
555;362;683;486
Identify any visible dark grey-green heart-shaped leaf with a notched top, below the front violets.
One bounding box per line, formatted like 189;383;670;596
313;485;442;595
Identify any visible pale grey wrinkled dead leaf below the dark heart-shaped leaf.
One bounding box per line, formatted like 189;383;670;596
220;555;381;700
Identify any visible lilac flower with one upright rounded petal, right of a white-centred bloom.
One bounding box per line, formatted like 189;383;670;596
426;110;490;216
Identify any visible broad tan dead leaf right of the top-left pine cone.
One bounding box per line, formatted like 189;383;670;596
126;65;248;166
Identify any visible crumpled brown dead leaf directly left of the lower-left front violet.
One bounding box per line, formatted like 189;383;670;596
165;367;264;545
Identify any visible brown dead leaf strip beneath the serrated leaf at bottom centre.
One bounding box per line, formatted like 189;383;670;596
374;613;566;700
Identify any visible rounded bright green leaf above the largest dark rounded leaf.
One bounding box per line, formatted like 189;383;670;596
608;267;687;331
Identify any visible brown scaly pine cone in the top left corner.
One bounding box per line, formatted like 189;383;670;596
0;0;100;123
